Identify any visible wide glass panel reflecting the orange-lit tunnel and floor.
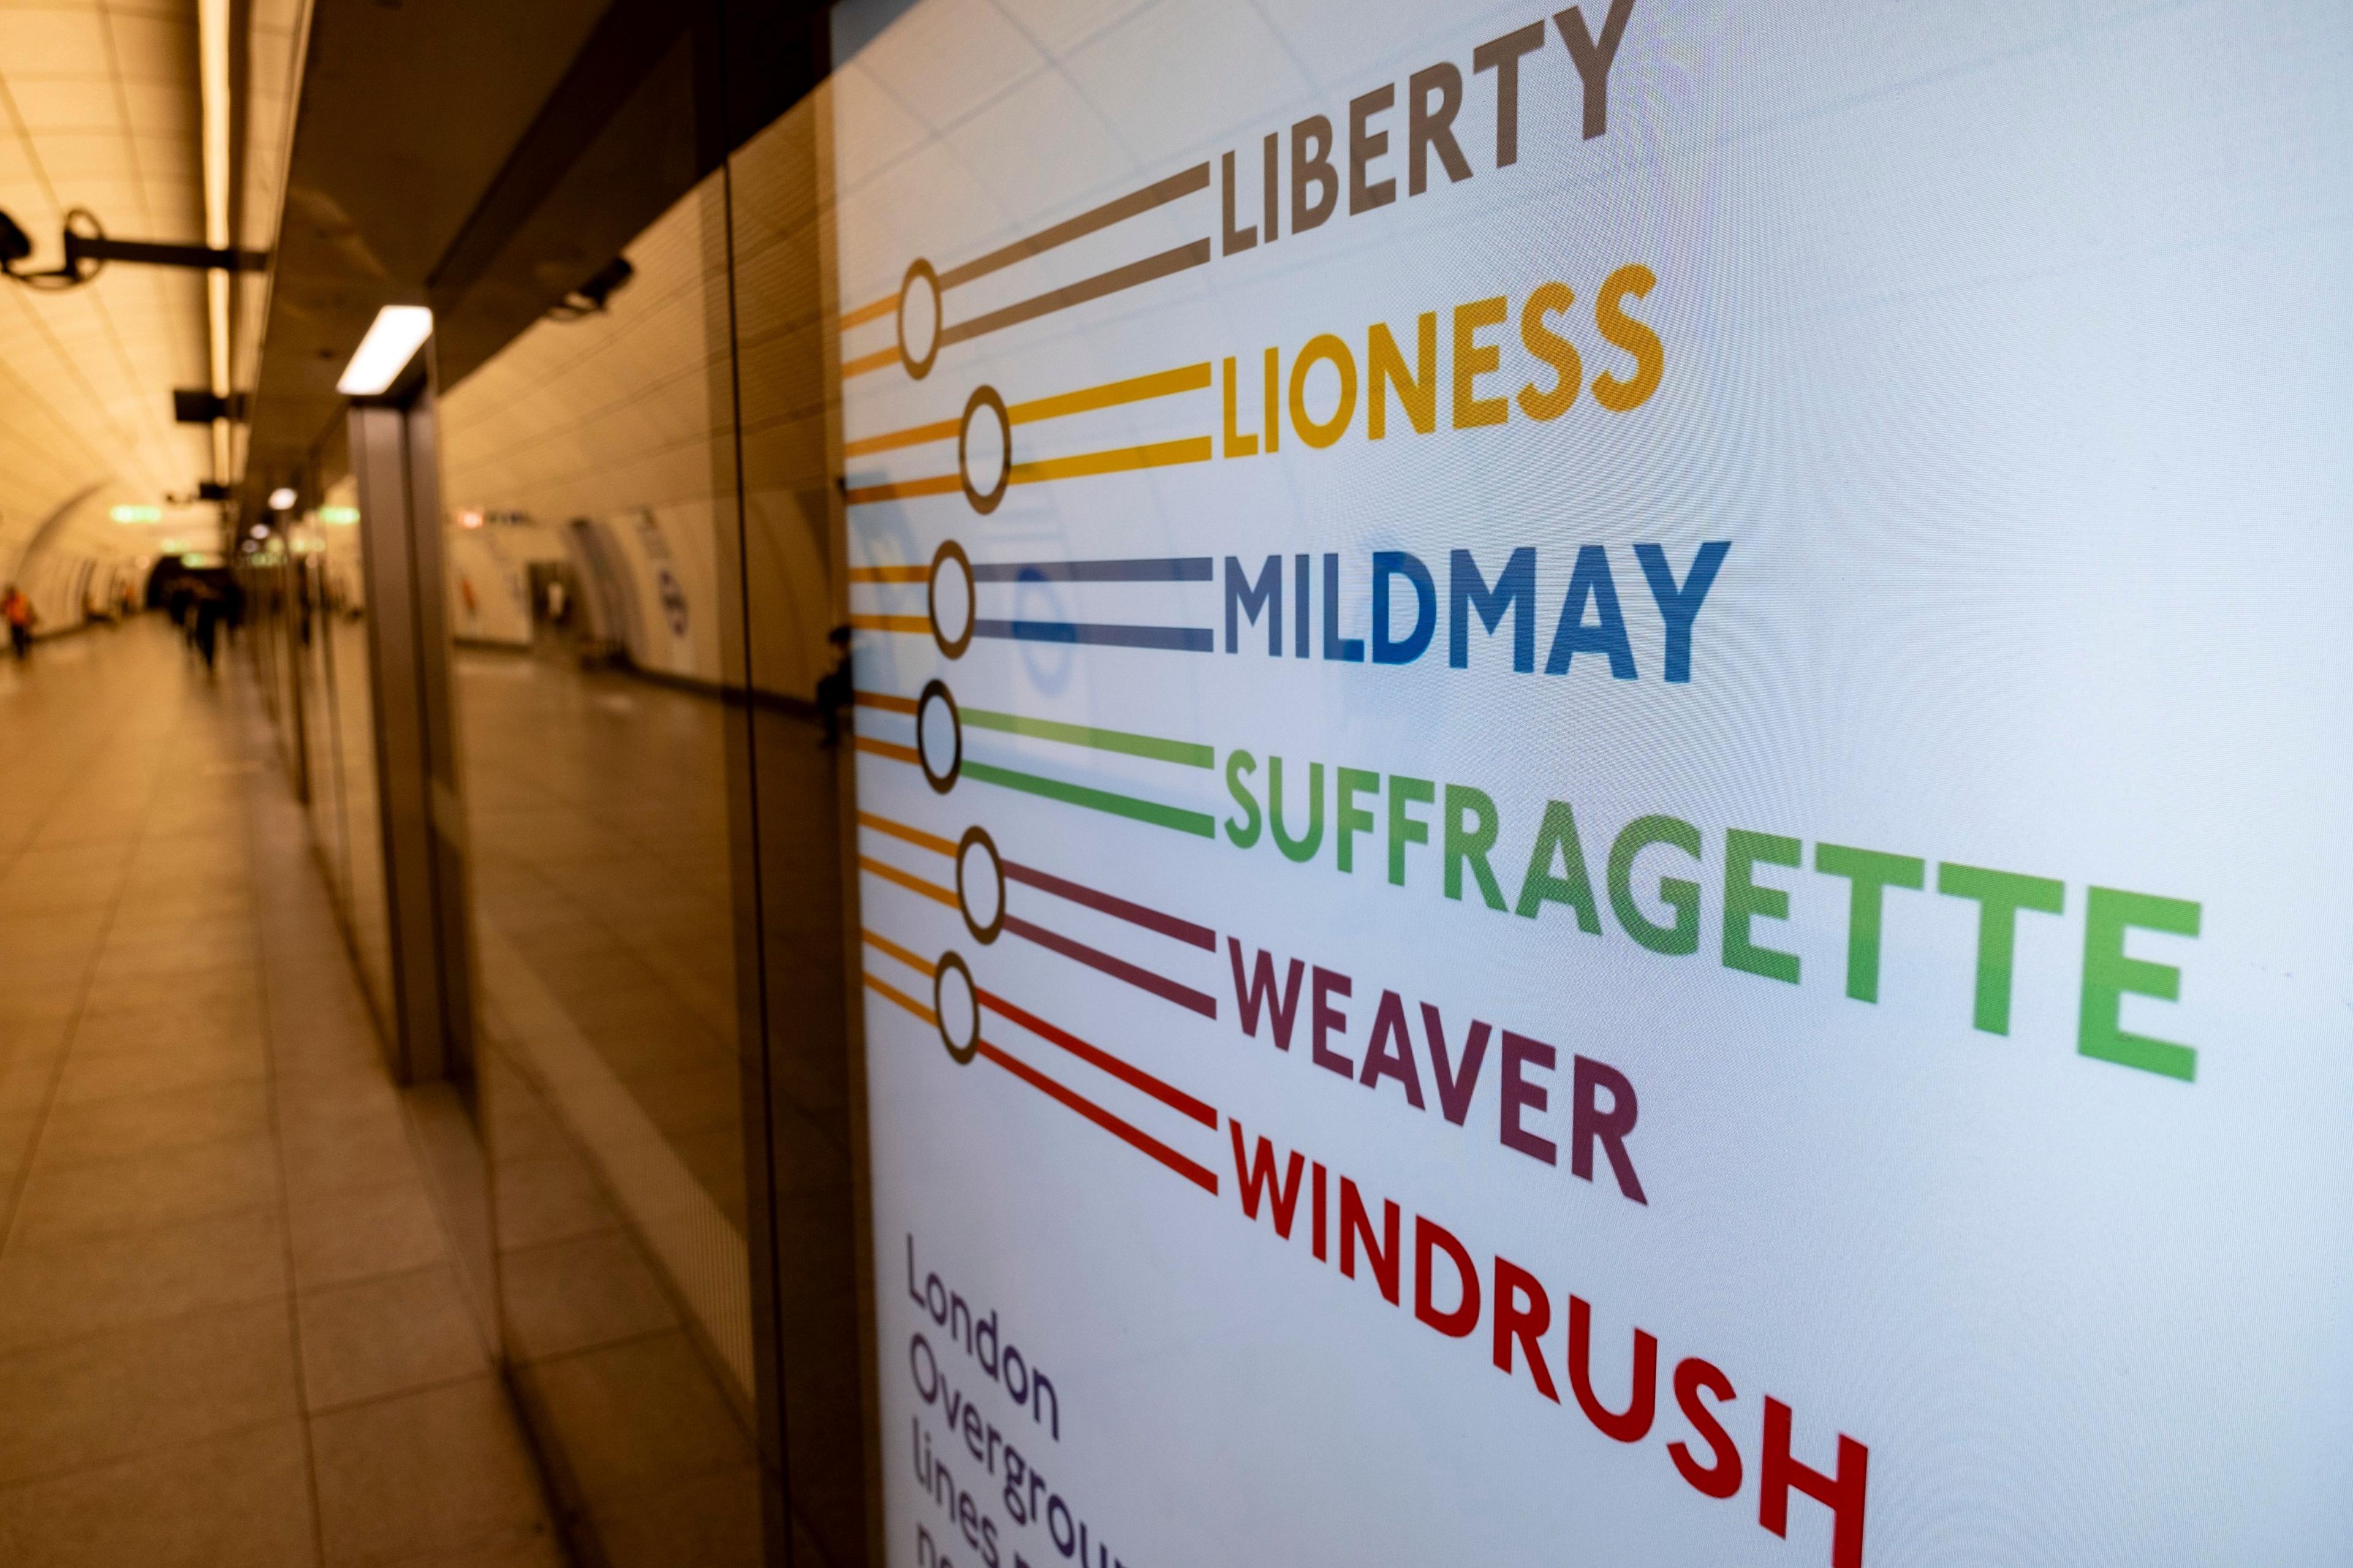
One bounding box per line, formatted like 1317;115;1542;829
440;164;760;1563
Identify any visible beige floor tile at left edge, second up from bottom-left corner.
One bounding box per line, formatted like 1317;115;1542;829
0;1300;299;1486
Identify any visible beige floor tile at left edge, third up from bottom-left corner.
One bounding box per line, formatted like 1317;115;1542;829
0;1200;287;1349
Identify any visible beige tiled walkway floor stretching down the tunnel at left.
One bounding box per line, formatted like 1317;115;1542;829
0;617;563;1568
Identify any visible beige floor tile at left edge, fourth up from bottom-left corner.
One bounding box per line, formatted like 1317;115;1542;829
9;1135;278;1248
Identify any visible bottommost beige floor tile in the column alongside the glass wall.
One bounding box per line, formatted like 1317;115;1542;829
311;1377;546;1566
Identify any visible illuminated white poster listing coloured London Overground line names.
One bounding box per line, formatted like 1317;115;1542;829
831;0;2353;1568
